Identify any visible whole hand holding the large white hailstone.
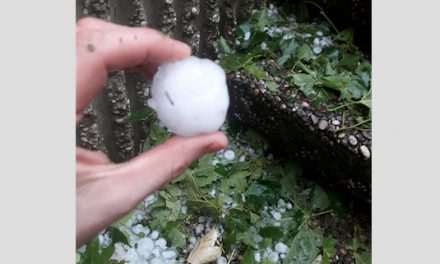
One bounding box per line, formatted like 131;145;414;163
76;18;227;247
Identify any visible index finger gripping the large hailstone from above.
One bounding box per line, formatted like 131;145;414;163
76;18;191;121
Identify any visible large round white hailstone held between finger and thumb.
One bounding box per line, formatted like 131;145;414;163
148;56;229;136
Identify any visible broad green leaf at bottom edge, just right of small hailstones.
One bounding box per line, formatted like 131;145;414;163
284;225;323;264
